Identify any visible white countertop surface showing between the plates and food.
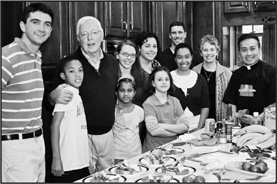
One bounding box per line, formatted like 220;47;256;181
76;129;276;182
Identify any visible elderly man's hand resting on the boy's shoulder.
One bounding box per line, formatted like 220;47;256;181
49;84;73;104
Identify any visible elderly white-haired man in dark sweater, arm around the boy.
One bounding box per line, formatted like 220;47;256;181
44;16;118;174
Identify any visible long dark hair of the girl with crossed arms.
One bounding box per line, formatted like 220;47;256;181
148;66;175;95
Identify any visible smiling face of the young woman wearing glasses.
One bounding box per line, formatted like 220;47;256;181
117;45;136;69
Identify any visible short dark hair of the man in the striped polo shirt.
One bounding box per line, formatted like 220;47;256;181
22;3;54;26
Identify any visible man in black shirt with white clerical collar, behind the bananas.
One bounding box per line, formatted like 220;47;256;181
222;33;276;124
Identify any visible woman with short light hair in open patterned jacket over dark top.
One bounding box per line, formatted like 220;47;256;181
193;35;232;121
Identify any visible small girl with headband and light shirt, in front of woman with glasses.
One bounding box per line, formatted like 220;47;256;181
113;75;144;164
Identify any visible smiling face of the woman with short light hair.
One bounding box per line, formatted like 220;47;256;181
201;42;218;63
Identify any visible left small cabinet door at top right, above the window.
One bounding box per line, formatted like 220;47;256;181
224;1;251;13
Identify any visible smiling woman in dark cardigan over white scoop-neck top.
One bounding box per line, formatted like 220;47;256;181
171;43;210;132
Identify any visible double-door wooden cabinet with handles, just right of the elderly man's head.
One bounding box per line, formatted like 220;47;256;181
105;1;147;38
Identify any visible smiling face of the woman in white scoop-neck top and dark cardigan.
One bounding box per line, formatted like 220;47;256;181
175;48;192;71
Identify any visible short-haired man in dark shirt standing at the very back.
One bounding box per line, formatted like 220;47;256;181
156;21;203;71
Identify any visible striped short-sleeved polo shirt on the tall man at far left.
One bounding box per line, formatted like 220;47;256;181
2;38;44;135
